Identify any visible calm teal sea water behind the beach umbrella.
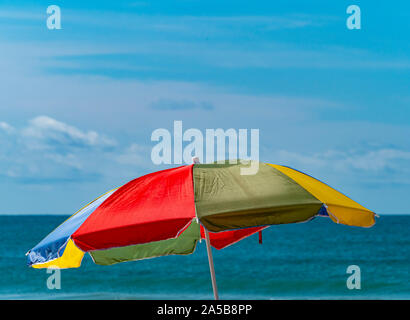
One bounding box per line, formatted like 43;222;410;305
0;216;410;299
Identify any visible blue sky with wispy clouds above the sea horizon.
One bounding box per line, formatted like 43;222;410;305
0;0;410;214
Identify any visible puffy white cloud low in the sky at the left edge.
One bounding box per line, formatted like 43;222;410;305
0;116;141;184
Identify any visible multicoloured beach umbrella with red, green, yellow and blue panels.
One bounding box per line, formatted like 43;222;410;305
27;162;375;299
